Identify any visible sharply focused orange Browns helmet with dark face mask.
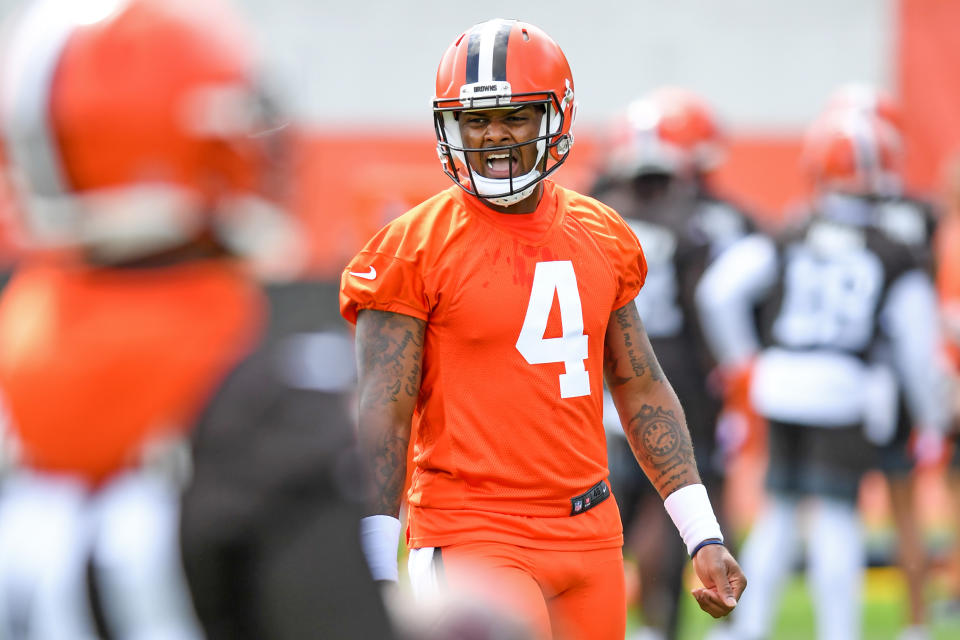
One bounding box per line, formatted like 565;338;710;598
433;19;577;205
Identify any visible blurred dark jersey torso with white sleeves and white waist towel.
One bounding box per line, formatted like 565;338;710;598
697;208;943;440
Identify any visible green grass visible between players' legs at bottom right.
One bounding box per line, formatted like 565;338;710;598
652;568;960;640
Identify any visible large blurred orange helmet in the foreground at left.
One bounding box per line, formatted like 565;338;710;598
0;0;284;256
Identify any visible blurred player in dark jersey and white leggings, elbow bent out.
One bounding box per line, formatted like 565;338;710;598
697;91;944;640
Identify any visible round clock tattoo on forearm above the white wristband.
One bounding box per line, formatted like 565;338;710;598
626;404;698;495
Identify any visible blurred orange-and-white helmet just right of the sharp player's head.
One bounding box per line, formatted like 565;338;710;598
609;86;724;176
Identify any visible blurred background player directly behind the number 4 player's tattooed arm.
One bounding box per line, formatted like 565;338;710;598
592;87;753;640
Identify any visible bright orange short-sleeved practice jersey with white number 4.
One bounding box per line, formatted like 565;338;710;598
340;180;646;549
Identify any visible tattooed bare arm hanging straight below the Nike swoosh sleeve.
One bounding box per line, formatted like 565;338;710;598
357;309;426;518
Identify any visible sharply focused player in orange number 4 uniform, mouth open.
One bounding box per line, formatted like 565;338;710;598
341;19;745;640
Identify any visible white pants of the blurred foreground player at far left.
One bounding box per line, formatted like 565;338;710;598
0;464;203;640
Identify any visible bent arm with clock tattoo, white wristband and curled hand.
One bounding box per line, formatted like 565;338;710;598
603;302;747;618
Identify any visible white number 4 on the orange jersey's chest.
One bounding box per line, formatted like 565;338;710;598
517;260;590;398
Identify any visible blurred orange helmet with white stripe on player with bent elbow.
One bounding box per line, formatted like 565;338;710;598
802;111;902;195
